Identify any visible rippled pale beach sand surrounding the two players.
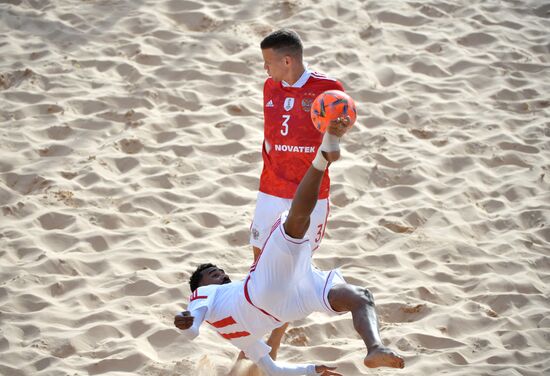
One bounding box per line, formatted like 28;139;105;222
0;0;550;376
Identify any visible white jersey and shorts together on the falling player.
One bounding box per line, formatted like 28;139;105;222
188;213;345;362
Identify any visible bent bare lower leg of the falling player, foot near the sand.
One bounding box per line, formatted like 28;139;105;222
328;284;405;368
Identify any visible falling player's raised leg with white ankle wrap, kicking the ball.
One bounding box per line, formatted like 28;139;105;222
284;116;351;239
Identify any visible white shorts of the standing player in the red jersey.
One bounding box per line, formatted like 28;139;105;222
250;192;329;251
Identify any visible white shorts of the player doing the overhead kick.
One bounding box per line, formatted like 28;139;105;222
245;213;345;322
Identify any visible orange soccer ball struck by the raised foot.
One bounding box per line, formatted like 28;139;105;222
311;90;357;133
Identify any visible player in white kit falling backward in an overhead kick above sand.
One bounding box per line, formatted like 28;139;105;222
174;118;404;376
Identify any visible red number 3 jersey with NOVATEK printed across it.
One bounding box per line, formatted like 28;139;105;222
260;69;344;199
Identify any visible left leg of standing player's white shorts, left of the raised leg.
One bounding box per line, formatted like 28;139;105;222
250;192;290;249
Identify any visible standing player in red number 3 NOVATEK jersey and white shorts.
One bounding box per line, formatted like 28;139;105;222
250;29;350;359
